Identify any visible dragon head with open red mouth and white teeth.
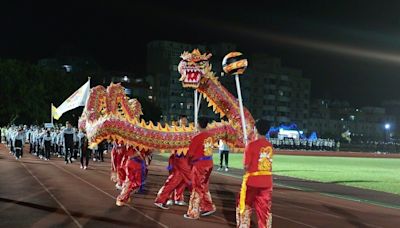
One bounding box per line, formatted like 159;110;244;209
178;49;212;89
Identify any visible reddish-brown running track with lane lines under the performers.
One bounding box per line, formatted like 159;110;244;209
0;144;400;228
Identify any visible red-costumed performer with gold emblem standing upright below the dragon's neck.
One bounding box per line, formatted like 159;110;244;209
183;118;216;219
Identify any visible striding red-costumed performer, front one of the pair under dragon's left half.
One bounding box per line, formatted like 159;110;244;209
116;146;146;206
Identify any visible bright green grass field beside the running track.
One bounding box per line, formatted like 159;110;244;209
160;153;400;195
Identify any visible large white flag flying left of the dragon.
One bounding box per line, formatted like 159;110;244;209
53;80;90;120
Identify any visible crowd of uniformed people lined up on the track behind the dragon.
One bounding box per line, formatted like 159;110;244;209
1;121;108;169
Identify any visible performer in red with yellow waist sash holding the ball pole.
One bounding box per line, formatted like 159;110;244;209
236;120;273;228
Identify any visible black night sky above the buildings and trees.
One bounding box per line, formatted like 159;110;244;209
0;0;400;106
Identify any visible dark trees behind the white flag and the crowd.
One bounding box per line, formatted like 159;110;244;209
0;59;161;126
